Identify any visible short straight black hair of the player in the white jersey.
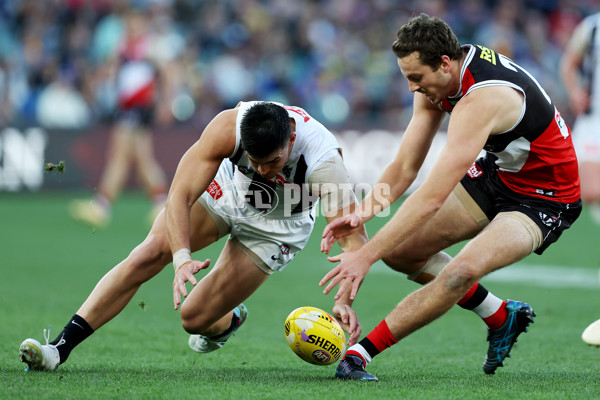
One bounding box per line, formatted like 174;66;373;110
240;102;292;158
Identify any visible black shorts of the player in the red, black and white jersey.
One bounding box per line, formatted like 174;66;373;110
460;155;581;254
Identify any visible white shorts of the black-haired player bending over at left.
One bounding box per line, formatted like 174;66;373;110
198;163;315;274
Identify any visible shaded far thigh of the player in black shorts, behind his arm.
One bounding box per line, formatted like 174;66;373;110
385;192;482;272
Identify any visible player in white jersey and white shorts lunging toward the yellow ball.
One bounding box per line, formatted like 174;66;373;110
20;102;366;370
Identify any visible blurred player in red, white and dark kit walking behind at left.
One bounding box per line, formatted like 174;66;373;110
69;10;172;227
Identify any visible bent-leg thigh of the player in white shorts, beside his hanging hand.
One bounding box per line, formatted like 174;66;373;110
181;240;270;326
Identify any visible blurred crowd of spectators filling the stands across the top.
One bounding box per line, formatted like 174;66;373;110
0;0;600;130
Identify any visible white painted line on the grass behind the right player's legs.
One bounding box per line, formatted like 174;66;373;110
372;262;600;289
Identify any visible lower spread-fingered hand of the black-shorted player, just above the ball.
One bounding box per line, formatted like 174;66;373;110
319;247;373;300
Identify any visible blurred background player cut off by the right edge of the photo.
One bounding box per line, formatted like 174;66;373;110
560;13;600;225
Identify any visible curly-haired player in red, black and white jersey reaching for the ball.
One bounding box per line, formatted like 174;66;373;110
320;14;581;381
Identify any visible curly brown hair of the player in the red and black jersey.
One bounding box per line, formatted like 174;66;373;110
392;14;462;71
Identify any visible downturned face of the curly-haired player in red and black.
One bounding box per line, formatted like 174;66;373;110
398;51;458;104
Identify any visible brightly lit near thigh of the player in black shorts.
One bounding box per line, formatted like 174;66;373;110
445;211;542;281
